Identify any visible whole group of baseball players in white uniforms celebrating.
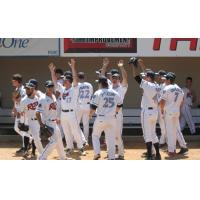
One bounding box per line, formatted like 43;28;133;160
12;58;196;160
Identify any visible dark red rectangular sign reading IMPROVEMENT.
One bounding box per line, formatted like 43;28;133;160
64;38;137;53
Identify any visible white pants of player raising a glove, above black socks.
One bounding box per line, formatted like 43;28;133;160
141;108;158;144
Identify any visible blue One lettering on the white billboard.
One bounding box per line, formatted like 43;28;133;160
0;38;29;49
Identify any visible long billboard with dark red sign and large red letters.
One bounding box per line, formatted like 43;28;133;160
60;38;200;57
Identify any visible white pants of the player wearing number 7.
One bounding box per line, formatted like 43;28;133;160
165;113;187;153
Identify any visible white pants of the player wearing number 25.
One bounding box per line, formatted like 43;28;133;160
92;117;117;159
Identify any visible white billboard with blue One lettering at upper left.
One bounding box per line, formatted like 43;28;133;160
0;38;60;56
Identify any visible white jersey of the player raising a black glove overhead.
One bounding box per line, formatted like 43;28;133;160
140;79;159;108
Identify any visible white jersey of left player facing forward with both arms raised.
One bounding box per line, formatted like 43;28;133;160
56;83;79;110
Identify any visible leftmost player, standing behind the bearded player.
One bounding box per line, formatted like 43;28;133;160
12;74;30;154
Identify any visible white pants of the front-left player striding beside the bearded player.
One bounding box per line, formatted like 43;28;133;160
39;122;65;160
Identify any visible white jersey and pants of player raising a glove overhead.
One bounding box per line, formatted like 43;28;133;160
140;79;159;144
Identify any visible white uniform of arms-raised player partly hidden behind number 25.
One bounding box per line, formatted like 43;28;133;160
112;84;128;156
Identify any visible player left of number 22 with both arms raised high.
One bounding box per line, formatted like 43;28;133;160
49;59;86;156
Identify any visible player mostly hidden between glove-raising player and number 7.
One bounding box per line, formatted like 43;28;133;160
157;70;167;147
